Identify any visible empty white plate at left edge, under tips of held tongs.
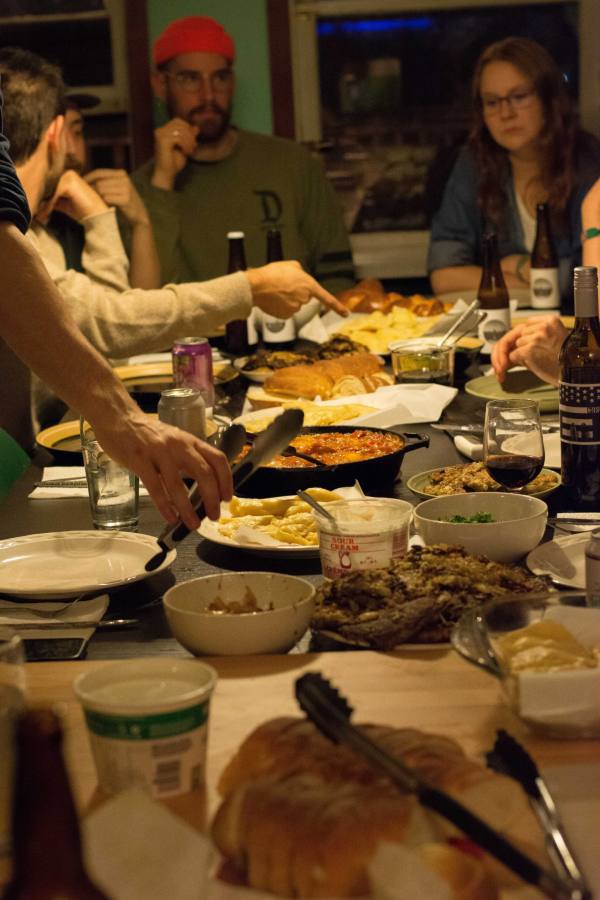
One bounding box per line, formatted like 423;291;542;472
0;531;177;600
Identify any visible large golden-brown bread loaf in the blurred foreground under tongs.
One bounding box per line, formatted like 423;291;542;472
211;717;539;900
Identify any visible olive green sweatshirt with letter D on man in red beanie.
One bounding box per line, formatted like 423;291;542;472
132;131;354;292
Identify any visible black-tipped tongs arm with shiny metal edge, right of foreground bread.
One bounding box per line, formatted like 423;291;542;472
486;729;591;897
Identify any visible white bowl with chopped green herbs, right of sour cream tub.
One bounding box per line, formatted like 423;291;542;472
413;491;548;562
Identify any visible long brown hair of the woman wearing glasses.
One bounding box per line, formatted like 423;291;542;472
469;37;576;224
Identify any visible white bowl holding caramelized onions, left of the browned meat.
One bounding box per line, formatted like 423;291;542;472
163;572;315;656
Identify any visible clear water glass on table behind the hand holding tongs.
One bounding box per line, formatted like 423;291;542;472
80;419;139;531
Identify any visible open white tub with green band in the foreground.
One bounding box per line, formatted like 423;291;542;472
73;659;217;798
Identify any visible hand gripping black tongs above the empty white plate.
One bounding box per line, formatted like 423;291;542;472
92;411;233;530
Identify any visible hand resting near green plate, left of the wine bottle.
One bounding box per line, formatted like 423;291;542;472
492;315;568;384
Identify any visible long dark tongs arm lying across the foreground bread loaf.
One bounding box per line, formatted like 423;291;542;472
295;672;591;900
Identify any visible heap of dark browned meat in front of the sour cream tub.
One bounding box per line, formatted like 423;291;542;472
311;544;548;650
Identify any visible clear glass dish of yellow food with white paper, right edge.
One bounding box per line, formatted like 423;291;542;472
452;591;600;739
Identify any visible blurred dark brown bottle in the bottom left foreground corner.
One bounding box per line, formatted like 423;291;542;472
3;709;108;900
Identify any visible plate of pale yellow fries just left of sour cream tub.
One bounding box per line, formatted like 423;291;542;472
198;483;364;558
